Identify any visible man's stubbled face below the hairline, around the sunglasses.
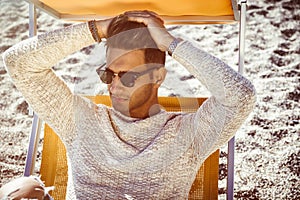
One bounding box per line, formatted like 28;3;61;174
107;48;158;118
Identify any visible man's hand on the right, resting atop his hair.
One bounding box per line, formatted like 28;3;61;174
124;10;175;51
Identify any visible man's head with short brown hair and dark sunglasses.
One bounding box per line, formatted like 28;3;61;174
100;12;166;118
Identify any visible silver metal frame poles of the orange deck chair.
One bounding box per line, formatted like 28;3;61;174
24;0;247;200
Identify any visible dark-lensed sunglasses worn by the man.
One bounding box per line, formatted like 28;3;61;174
96;64;160;87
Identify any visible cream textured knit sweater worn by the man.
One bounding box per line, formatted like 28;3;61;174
3;23;255;199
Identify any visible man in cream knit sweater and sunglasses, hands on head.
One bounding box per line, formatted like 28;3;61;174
4;11;255;199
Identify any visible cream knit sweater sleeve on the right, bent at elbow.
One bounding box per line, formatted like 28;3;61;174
173;41;256;159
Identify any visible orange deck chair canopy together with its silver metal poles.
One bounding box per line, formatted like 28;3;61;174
24;0;247;200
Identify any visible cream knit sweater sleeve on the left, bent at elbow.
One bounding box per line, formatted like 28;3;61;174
3;23;94;144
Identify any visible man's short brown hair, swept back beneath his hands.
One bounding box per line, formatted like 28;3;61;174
107;14;166;65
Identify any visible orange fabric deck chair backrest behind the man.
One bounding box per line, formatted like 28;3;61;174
40;96;219;200
